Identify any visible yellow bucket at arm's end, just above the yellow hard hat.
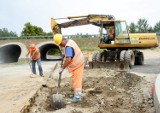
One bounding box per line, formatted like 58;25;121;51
51;18;61;35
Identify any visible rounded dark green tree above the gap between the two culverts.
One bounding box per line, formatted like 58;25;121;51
21;22;46;36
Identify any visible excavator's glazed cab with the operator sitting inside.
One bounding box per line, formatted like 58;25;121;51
100;20;130;44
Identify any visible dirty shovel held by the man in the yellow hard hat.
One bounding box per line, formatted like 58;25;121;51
51;73;64;110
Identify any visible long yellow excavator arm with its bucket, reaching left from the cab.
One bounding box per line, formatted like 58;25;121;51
51;14;114;34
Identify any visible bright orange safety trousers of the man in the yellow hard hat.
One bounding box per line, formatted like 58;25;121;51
72;63;84;93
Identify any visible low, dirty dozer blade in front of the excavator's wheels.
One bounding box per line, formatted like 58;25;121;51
89;61;130;71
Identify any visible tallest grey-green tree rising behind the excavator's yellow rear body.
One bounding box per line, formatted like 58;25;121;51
137;19;149;33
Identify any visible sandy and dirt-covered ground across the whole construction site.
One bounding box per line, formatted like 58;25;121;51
0;48;160;113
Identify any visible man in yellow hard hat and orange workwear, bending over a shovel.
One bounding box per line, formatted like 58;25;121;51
54;34;84;102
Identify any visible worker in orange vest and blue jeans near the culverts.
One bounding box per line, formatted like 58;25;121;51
26;44;43;77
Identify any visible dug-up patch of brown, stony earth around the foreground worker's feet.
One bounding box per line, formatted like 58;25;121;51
22;69;155;113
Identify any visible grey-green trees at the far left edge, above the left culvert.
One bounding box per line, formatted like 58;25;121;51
0;28;18;37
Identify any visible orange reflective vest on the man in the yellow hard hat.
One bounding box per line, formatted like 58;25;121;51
64;39;84;72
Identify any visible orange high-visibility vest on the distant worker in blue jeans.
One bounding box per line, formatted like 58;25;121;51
29;48;41;60
